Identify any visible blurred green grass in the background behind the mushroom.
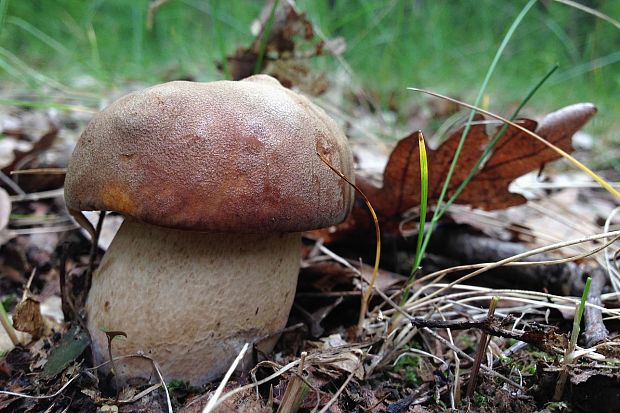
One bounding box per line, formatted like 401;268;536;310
0;0;620;168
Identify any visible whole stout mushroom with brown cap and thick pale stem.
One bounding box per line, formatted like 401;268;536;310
65;75;353;384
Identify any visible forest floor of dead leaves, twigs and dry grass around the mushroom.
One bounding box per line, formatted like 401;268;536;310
0;1;620;413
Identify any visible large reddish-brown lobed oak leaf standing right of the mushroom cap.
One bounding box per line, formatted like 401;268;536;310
357;103;596;218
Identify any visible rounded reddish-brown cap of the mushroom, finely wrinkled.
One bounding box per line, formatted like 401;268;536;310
65;75;353;233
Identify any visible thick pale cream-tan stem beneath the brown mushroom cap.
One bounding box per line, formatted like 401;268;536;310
86;219;301;384
